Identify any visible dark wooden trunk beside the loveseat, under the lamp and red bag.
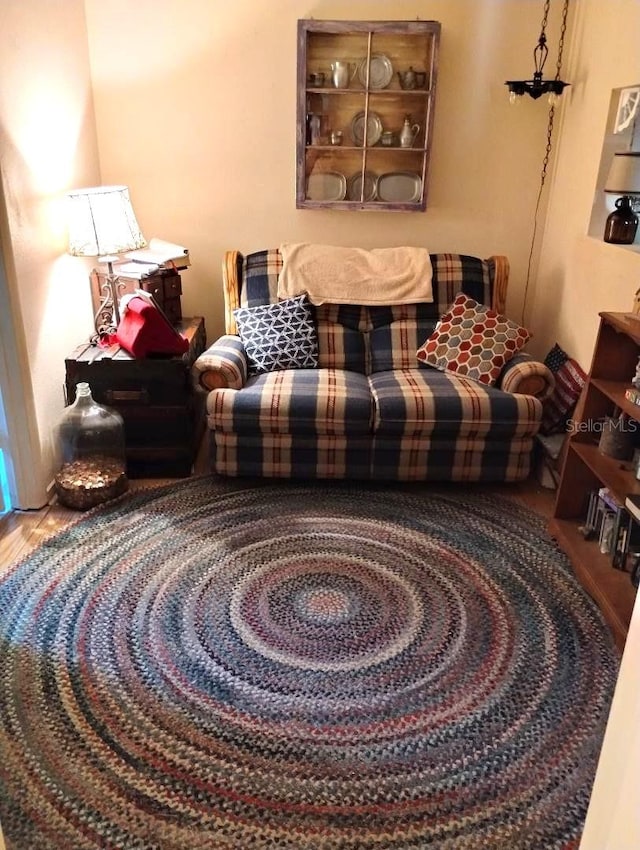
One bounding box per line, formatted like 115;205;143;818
65;317;206;478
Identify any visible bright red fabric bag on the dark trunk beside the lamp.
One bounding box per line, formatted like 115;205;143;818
116;296;189;357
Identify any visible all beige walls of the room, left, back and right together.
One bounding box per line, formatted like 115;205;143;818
0;0;640;496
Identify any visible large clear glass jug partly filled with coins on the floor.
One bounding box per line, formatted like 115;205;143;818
55;382;129;511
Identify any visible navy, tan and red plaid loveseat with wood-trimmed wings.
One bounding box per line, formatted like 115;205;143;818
192;250;553;481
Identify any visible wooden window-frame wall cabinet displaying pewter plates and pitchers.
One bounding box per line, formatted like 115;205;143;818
296;20;440;212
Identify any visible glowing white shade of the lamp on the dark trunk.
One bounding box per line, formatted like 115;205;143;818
67;186;147;258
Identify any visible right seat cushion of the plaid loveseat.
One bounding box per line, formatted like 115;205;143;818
369;369;542;442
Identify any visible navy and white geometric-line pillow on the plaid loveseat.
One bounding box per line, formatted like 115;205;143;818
233;294;318;374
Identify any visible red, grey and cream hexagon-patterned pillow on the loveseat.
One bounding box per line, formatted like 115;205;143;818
416;292;531;386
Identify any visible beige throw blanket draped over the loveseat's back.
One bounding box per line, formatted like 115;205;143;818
278;242;433;306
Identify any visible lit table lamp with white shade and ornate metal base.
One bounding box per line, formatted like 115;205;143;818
67;186;147;339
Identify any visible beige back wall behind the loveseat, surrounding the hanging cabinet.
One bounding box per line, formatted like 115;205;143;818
87;0;560;339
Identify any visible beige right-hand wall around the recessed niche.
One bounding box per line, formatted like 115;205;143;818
532;0;640;366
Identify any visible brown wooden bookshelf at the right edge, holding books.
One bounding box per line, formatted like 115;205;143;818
549;312;640;649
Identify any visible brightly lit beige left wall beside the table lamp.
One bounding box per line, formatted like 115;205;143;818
0;0;99;507
